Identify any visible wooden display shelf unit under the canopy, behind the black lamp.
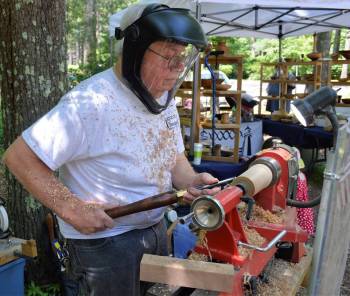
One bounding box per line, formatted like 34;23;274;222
258;61;322;118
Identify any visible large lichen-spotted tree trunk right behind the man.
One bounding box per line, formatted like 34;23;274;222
0;0;67;282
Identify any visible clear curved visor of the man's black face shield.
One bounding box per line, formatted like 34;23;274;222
140;41;199;104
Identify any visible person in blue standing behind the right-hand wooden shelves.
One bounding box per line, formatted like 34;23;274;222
266;66;296;113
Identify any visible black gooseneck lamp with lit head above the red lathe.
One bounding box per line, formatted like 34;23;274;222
291;86;339;147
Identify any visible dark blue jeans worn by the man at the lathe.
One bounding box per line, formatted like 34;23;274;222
67;219;168;296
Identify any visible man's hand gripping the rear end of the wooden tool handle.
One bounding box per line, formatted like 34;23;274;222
61;200;114;234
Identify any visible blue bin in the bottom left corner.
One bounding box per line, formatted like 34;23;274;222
0;258;25;296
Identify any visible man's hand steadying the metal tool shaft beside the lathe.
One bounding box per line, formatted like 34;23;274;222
184;173;220;202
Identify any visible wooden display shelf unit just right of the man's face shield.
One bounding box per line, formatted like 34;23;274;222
176;56;243;163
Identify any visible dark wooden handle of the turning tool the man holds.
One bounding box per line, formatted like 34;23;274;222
105;191;178;219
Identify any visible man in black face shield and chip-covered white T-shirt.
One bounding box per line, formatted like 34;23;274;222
4;4;217;296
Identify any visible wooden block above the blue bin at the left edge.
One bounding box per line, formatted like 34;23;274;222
0;237;38;265
